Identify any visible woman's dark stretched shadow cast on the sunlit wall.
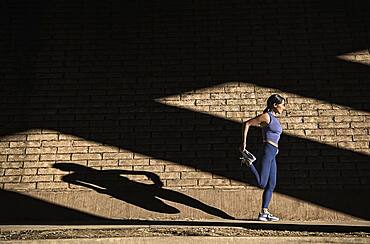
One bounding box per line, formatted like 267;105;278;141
53;163;234;219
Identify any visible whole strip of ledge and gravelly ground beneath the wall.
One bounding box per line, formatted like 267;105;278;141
0;220;370;244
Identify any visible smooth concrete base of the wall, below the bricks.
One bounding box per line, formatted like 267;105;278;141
0;188;369;224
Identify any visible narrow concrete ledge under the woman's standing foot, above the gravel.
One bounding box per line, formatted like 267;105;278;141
0;220;370;233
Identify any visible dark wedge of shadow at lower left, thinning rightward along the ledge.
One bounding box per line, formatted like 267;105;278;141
0;189;370;233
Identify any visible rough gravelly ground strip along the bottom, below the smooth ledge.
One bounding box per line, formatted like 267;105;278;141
0;227;370;242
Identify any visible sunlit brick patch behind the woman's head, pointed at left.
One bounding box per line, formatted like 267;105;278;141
155;82;370;154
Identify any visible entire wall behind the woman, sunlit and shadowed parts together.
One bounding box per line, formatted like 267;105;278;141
0;0;370;219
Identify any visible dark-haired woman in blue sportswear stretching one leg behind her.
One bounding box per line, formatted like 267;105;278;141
240;94;285;221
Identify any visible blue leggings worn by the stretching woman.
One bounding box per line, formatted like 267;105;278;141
250;143;279;208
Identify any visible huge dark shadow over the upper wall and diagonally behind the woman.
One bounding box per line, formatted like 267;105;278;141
0;1;370;220
